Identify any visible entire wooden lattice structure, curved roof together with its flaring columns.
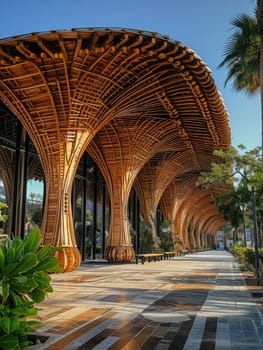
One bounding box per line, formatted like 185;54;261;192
0;28;230;271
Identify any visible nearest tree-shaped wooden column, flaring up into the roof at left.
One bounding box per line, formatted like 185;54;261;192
0;32;133;271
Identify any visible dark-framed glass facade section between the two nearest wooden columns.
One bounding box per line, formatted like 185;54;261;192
72;153;110;260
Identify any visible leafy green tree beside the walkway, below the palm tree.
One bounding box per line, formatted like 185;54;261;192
197;145;263;245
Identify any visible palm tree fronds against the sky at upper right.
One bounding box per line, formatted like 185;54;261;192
219;9;263;146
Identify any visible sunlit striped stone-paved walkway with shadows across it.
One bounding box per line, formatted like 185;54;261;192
26;251;263;350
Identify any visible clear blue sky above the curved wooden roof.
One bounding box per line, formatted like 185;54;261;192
0;0;261;149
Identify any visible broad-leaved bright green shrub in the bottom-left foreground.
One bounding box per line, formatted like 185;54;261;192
0;228;61;350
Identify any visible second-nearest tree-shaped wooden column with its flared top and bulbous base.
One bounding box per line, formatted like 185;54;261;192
87;117;177;262
